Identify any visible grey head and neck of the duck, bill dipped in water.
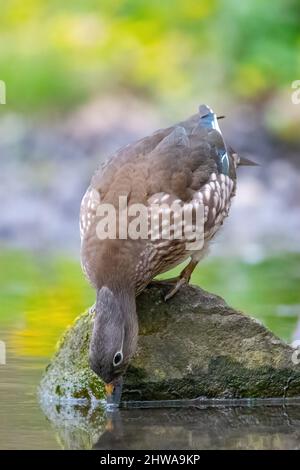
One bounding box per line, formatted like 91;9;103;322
90;286;138;404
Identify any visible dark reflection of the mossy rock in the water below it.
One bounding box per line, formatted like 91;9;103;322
42;398;300;449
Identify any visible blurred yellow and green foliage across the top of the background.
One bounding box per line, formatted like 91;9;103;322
0;0;300;113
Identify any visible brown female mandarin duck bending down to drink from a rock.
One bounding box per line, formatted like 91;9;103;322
80;105;251;400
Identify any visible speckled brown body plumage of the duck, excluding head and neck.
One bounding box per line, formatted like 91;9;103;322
81;105;237;292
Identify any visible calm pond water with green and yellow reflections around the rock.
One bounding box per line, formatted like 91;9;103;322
0;252;300;449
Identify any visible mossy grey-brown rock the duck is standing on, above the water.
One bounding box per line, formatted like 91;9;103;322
40;286;300;402
